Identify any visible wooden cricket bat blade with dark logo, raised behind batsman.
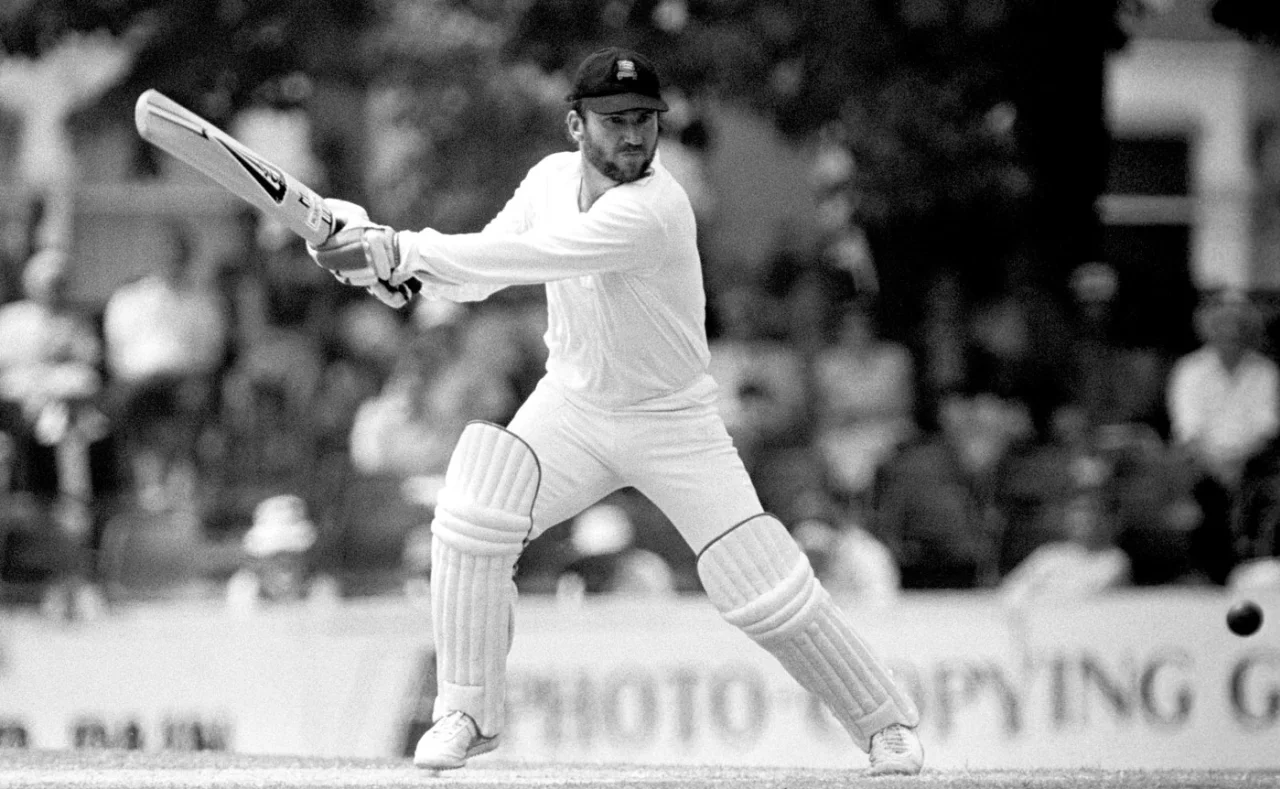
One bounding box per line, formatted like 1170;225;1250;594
133;88;334;245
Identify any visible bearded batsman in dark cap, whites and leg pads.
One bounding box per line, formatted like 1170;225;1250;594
310;47;923;775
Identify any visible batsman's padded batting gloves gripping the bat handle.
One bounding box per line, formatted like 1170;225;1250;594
307;199;417;309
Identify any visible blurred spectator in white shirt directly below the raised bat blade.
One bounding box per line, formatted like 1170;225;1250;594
102;227;228;507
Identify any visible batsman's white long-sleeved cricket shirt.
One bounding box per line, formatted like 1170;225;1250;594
399;151;716;410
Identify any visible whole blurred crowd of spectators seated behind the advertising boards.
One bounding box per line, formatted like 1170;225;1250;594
0;204;1280;616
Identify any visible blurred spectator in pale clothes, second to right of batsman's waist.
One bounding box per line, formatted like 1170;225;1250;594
814;302;915;509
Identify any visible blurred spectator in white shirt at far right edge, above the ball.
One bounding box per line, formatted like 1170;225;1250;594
1166;292;1280;584
